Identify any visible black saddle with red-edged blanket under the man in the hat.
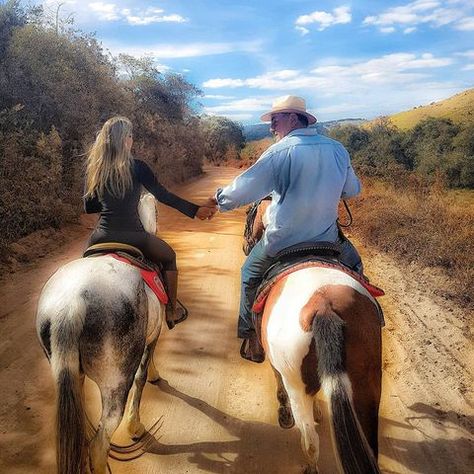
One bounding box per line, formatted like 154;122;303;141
248;242;385;361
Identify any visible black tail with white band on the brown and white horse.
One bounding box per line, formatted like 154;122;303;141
313;312;380;474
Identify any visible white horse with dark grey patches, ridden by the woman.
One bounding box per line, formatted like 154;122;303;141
36;194;165;474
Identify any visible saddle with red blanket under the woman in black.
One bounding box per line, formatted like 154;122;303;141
83;242;169;304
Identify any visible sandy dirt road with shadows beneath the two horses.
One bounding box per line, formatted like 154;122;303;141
0;168;474;474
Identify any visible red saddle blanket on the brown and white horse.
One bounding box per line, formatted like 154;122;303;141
252;260;385;314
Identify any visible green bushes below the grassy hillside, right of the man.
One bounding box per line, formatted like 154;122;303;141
330;117;474;188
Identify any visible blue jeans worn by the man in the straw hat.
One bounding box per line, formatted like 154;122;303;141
237;237;363;339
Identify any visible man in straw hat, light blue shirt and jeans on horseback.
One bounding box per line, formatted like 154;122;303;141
209;96;362;362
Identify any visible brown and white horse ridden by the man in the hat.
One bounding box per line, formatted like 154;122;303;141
244;201;381;474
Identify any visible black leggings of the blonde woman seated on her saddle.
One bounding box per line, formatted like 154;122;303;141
89;229;177;271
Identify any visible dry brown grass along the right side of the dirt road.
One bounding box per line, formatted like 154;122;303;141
352;180;474;306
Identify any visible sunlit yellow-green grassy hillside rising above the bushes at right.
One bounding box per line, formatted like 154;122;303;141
390;89;474;130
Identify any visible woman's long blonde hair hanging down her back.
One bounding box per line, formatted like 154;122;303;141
85;116;132;197
